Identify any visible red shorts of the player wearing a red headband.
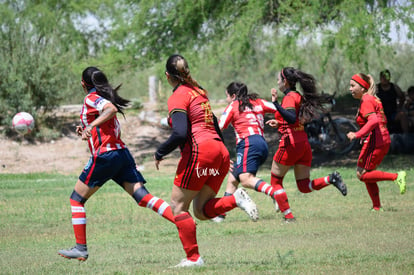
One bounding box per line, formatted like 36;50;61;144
357;142;390;171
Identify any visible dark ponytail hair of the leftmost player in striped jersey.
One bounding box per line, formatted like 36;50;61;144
82;67;130;116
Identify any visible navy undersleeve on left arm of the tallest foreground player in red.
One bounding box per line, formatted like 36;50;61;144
155;112;188;160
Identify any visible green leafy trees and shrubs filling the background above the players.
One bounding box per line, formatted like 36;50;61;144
0;0;414;133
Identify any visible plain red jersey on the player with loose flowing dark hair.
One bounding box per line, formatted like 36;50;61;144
275;91;308;146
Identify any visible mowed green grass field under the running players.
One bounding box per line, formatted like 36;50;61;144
0;161;414;274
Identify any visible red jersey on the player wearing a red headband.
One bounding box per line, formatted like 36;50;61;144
356;94;391;147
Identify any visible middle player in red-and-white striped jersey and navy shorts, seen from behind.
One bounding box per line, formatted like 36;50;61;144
213;82;277;222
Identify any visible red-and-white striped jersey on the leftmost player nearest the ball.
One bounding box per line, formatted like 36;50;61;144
80;90;126;155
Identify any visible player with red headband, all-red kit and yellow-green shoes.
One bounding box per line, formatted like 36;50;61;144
347;73;406;211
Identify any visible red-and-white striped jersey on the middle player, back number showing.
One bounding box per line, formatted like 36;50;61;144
219;99;276;143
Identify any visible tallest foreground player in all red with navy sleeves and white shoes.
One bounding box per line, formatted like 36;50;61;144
154;54;257;267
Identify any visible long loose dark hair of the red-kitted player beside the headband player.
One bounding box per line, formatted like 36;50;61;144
280;67;327;123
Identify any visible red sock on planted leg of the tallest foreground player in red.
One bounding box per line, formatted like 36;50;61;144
174;212;200;261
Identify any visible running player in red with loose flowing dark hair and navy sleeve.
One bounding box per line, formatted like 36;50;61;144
266;67;347;222
